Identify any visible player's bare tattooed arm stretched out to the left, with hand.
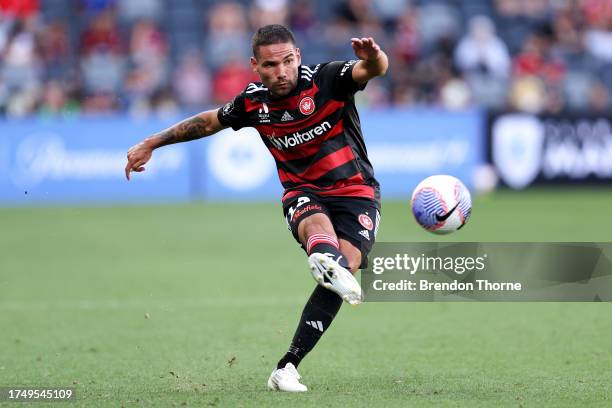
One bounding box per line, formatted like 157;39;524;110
125;109;225;180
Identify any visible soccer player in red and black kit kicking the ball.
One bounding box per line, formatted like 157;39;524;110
125;25;388;392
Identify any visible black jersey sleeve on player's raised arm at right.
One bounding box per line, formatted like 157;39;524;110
317;60;367;100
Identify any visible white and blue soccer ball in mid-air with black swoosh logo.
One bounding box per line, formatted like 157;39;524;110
411;175;472;234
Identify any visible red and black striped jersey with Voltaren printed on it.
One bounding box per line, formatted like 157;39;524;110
218;60;380;201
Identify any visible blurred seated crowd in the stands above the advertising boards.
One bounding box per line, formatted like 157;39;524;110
0;0;612;117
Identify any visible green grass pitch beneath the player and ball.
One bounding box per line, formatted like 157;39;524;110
0;189;612;407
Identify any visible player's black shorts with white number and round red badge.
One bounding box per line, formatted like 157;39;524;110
283;193;380;269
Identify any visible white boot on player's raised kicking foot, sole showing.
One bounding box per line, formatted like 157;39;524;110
308;252;363;305
